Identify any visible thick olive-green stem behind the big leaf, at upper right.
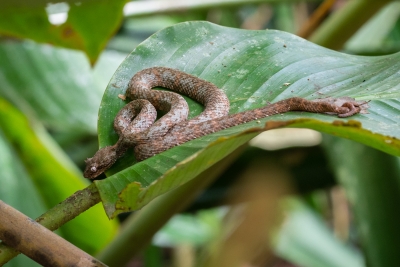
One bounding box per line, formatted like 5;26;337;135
309;0;391;50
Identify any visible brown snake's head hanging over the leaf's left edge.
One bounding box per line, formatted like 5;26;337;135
83;146;118;179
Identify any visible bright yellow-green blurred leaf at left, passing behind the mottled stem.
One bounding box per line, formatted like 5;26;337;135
0;99;116;253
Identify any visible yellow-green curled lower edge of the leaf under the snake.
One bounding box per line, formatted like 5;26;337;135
95;118;400;219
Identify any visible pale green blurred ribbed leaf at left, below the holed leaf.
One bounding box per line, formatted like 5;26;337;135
0;42;123;134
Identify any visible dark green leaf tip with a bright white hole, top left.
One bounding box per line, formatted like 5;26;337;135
0;0;126;63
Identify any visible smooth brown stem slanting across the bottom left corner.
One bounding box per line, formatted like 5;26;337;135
0;200;106;267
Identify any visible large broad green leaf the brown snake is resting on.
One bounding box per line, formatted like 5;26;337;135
96;22;400;219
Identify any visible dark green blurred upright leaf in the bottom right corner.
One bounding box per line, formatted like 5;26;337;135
323;136;400;266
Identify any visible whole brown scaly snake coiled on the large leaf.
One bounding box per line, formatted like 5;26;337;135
84;67;361;179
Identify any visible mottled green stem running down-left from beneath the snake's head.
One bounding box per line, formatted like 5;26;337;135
0;184;100;266
